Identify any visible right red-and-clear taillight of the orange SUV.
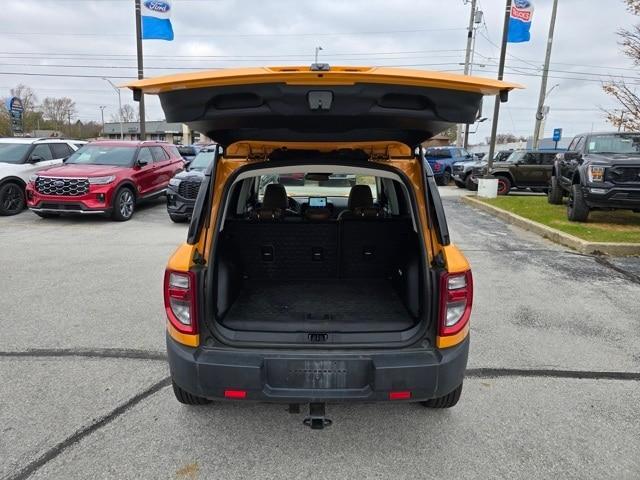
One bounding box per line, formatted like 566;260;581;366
438;270;473;337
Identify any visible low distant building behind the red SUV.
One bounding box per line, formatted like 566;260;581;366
101;121;208;145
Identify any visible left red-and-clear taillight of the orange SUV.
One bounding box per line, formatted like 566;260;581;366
164;270;198;335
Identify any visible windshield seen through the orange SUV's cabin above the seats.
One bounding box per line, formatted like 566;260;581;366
258;172;378;200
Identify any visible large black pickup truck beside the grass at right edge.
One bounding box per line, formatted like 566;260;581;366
547;132;640;222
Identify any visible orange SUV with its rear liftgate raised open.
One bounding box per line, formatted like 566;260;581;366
129;65;516;428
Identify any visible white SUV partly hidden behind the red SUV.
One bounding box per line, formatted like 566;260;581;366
0;138;87;215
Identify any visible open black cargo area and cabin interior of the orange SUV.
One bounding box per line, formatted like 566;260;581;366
210;164;424;339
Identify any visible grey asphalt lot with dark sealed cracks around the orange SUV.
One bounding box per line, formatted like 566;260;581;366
0;187;640;479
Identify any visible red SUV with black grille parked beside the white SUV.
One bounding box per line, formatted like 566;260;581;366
26;141;184;222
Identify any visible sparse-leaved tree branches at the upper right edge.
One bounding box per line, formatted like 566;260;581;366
602;0;640;131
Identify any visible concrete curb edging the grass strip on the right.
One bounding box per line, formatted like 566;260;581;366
460;196;640;256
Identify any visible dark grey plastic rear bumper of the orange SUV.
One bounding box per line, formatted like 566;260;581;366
167;336;469;403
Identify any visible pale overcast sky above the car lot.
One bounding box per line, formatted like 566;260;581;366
0;0;640;143
